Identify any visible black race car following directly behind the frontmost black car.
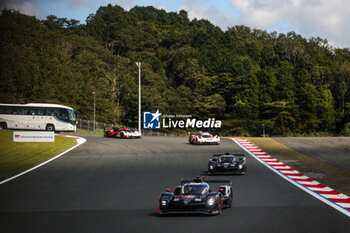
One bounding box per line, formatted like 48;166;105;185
208;152;247;175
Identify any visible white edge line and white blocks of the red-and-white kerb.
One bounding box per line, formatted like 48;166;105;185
231;138;350;217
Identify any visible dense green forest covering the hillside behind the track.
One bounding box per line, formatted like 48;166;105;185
0;4;350;136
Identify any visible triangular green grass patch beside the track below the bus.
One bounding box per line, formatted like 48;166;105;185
0;130;77;180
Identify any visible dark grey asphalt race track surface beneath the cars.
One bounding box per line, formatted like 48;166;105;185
0;135;350;233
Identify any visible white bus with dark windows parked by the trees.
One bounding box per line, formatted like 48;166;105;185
0;104;76;132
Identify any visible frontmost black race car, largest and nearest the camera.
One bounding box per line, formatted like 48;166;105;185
158;178;232;215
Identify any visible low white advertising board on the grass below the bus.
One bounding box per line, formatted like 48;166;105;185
13;131;55;142
